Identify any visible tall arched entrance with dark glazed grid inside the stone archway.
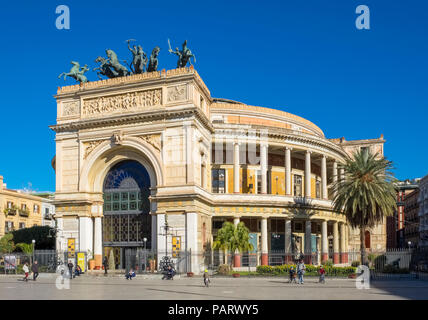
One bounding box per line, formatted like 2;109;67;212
103;160;152;269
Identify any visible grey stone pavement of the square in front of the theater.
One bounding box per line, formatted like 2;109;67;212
0;274;428;300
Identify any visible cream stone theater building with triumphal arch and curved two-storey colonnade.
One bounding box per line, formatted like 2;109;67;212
51;68;386;273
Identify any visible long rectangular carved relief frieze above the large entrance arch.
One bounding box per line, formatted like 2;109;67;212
83;89;162;117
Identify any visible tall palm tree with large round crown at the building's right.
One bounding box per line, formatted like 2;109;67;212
333;150;397;264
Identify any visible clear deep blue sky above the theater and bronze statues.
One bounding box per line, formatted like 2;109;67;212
0;0;428;191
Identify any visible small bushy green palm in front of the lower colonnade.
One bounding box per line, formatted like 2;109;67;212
213;221;254;264
